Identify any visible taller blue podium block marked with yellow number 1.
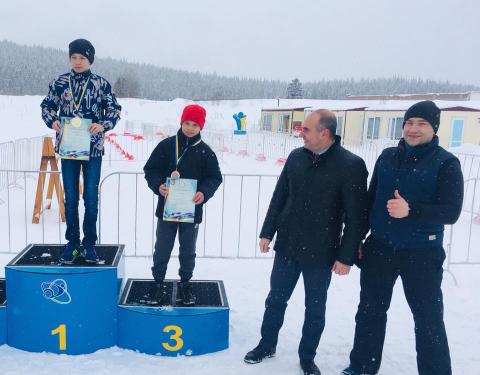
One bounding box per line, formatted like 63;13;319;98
5;244;124;354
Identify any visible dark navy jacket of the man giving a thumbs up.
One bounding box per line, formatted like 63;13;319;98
368;136;463;249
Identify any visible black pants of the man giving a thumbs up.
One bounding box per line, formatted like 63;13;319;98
350;237;452;375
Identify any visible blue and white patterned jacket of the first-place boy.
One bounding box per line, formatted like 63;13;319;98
40;70;122;157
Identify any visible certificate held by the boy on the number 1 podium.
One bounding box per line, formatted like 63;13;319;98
58;117;92;160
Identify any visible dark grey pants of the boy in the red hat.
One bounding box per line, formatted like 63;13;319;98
152;219;198;282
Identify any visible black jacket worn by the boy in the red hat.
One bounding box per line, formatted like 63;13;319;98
143;129;222;223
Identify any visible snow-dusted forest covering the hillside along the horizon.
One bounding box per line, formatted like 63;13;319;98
0;41;480;100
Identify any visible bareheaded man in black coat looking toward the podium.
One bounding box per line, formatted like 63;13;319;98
245;110;368;374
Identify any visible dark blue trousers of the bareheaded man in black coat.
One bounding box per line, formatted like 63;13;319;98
260;253;332;361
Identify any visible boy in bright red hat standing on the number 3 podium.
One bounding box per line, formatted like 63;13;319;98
143;104;222;305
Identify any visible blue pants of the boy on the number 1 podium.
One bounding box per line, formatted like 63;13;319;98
62;157;102;246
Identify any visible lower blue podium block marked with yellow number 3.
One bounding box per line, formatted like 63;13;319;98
118;279;229;356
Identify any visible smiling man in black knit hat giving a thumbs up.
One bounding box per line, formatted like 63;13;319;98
342;101;463;375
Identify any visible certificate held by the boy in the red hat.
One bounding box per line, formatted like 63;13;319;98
163;177;197;223
